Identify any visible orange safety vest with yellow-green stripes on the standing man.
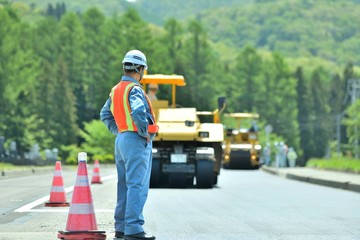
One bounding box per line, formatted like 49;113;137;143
110;81;159;133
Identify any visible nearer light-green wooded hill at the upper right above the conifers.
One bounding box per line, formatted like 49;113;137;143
199;0;360;64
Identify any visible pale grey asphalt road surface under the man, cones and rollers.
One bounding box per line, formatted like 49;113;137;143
0;165;360;240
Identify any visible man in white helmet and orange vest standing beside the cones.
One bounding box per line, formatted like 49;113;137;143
100;50;158;240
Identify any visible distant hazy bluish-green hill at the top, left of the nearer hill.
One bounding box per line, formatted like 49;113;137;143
10;0;254;25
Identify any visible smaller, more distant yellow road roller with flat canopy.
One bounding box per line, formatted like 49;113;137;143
223;113;261;169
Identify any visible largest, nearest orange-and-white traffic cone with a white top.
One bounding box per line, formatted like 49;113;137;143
58;152;106;240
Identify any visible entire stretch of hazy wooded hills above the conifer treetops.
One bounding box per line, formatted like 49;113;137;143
9;0;360;65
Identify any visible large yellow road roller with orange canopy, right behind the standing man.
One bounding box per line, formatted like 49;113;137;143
141;74;225;188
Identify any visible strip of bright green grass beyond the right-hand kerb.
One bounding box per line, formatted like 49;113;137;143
306;158;360;173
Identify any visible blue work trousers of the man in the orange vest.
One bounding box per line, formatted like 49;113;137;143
114;132;152;234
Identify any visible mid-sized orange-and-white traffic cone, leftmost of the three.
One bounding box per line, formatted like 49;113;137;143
45;161;70;207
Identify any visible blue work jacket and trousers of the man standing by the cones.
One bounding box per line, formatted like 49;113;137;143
100;76;154;235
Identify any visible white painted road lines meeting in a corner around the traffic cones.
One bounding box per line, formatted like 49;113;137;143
14;174;117;213
